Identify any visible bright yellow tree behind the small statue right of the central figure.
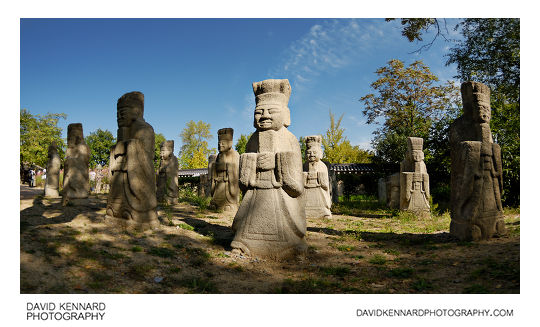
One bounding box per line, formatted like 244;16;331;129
320;110;371;163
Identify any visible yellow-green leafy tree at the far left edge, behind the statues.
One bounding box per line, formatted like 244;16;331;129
20;109;67;167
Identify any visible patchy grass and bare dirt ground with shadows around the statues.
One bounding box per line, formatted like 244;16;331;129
20;190;520;293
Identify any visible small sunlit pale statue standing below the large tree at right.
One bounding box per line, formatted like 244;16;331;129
399;137;429;216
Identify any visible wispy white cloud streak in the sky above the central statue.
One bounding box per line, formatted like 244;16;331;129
270;19;391;90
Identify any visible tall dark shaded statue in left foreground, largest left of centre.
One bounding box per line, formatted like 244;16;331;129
107;92;159;226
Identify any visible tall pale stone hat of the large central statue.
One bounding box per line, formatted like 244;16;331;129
253;79;291;127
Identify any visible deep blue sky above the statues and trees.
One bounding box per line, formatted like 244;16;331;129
20;19;455;153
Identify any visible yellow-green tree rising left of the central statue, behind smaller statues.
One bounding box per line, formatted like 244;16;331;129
178;120;216;169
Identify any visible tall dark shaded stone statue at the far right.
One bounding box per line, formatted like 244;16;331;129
450;82;506;240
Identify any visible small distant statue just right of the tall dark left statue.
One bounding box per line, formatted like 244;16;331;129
156;140;178;204
